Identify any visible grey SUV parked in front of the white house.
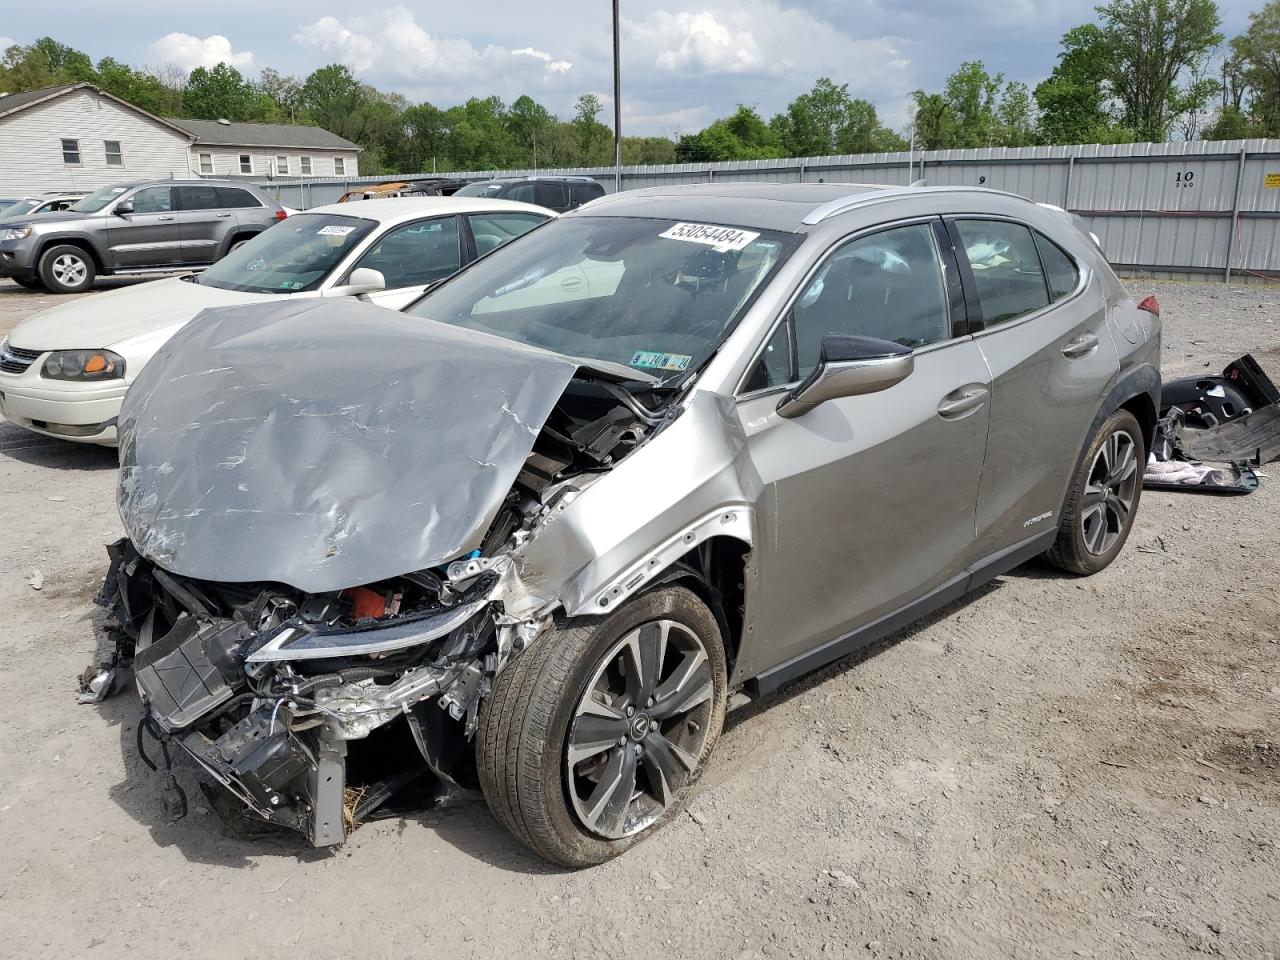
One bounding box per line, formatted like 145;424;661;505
0;180;285;293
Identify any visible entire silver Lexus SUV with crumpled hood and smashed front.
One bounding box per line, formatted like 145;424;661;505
90;184;1160;867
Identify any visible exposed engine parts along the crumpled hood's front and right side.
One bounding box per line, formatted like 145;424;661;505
88;370;676;846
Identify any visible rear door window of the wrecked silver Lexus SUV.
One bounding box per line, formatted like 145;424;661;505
956;220;1048;326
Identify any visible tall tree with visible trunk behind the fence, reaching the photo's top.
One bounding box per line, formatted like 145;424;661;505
1097;0;1222;141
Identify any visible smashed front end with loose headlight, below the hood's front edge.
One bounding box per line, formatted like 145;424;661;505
90;540;522;846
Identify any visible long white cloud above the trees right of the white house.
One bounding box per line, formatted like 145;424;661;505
293;6;573;86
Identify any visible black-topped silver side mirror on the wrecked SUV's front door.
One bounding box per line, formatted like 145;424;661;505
778;333;915;420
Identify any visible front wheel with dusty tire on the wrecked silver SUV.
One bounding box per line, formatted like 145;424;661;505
476;586;727;868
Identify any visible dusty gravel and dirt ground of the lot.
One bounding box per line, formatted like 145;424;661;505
0;273;1280;960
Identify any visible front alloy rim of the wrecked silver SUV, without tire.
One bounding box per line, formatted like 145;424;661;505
564;620;716;840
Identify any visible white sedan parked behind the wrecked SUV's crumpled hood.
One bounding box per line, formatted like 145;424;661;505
0;197;556;445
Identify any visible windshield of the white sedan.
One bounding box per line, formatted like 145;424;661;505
196;214;376;293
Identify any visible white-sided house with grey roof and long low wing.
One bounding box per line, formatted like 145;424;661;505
0;83;360;197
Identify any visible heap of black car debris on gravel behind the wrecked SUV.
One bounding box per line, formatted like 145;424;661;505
1142;353;1280;494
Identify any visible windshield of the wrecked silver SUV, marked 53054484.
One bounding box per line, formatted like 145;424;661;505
407;216;799;380
